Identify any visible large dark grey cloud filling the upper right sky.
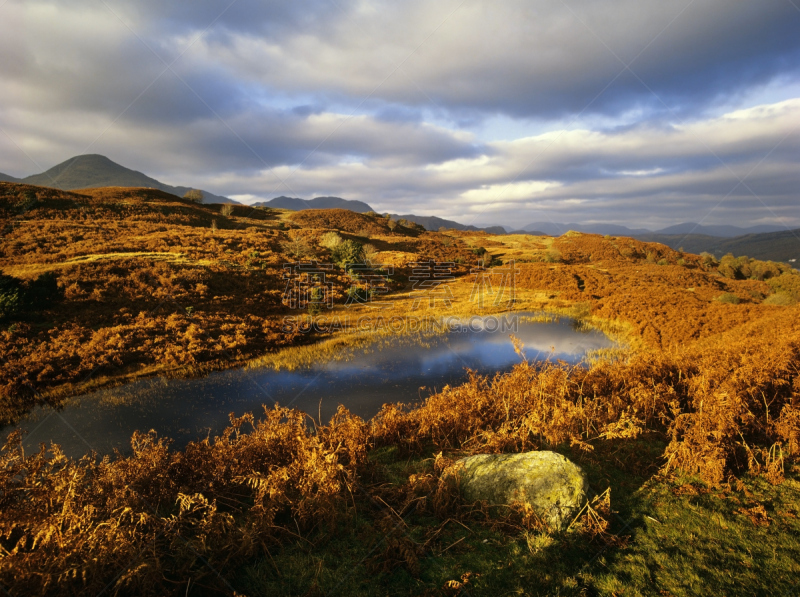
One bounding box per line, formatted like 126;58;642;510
180;0;800;121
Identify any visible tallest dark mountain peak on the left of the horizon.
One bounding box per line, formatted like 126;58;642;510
0;154;237;203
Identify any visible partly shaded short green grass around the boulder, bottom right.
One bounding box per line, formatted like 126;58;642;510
235;438;800;597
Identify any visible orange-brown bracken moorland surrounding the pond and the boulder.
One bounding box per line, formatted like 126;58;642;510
0;183;800;595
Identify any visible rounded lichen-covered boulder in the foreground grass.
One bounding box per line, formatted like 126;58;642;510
455;451;589;529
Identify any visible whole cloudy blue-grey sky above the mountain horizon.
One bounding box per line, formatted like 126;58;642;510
0;0;800;229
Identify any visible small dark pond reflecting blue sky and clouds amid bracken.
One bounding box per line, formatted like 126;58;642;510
6;313;614;456
